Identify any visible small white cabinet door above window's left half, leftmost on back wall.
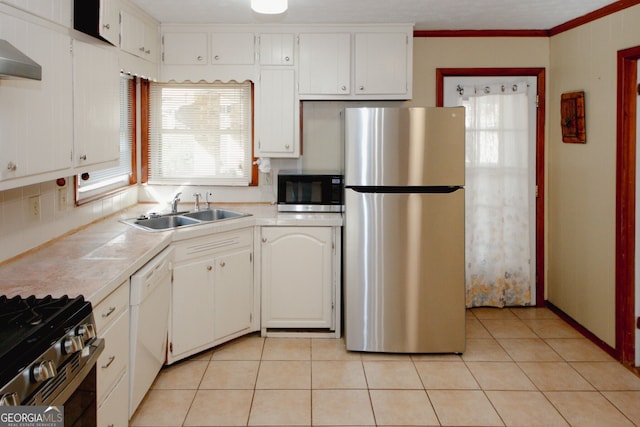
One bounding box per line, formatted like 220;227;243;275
162;33;209;65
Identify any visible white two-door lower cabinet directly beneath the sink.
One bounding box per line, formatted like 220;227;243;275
167;228;253;363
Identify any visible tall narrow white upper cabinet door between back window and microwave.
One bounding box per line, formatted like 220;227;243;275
256;68;300;157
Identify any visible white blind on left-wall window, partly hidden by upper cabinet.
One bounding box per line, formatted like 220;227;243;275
78;74;135;200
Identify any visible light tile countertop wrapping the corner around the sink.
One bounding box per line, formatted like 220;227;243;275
0;203;342;306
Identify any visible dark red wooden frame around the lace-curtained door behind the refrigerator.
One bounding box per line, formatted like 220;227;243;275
436;68;546;307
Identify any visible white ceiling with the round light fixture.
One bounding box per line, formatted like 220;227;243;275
132;0;614;30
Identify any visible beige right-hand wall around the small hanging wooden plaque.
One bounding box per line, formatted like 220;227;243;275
547;6;640;346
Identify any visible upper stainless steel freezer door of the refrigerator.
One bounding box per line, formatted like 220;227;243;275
345;107;465;186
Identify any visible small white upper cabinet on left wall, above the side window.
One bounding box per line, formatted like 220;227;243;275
120;10;160;62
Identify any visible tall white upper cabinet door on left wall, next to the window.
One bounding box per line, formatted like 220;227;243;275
73;40;120;172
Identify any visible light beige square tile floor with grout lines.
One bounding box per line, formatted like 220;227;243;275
130;308;640;427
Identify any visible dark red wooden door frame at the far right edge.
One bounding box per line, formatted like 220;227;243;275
615;46;640;367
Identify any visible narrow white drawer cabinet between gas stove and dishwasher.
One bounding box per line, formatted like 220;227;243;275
93;281;129;427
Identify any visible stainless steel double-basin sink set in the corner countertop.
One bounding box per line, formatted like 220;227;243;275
121;209;251;231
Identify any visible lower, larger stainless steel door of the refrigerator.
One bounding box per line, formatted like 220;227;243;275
344;189;465;353
